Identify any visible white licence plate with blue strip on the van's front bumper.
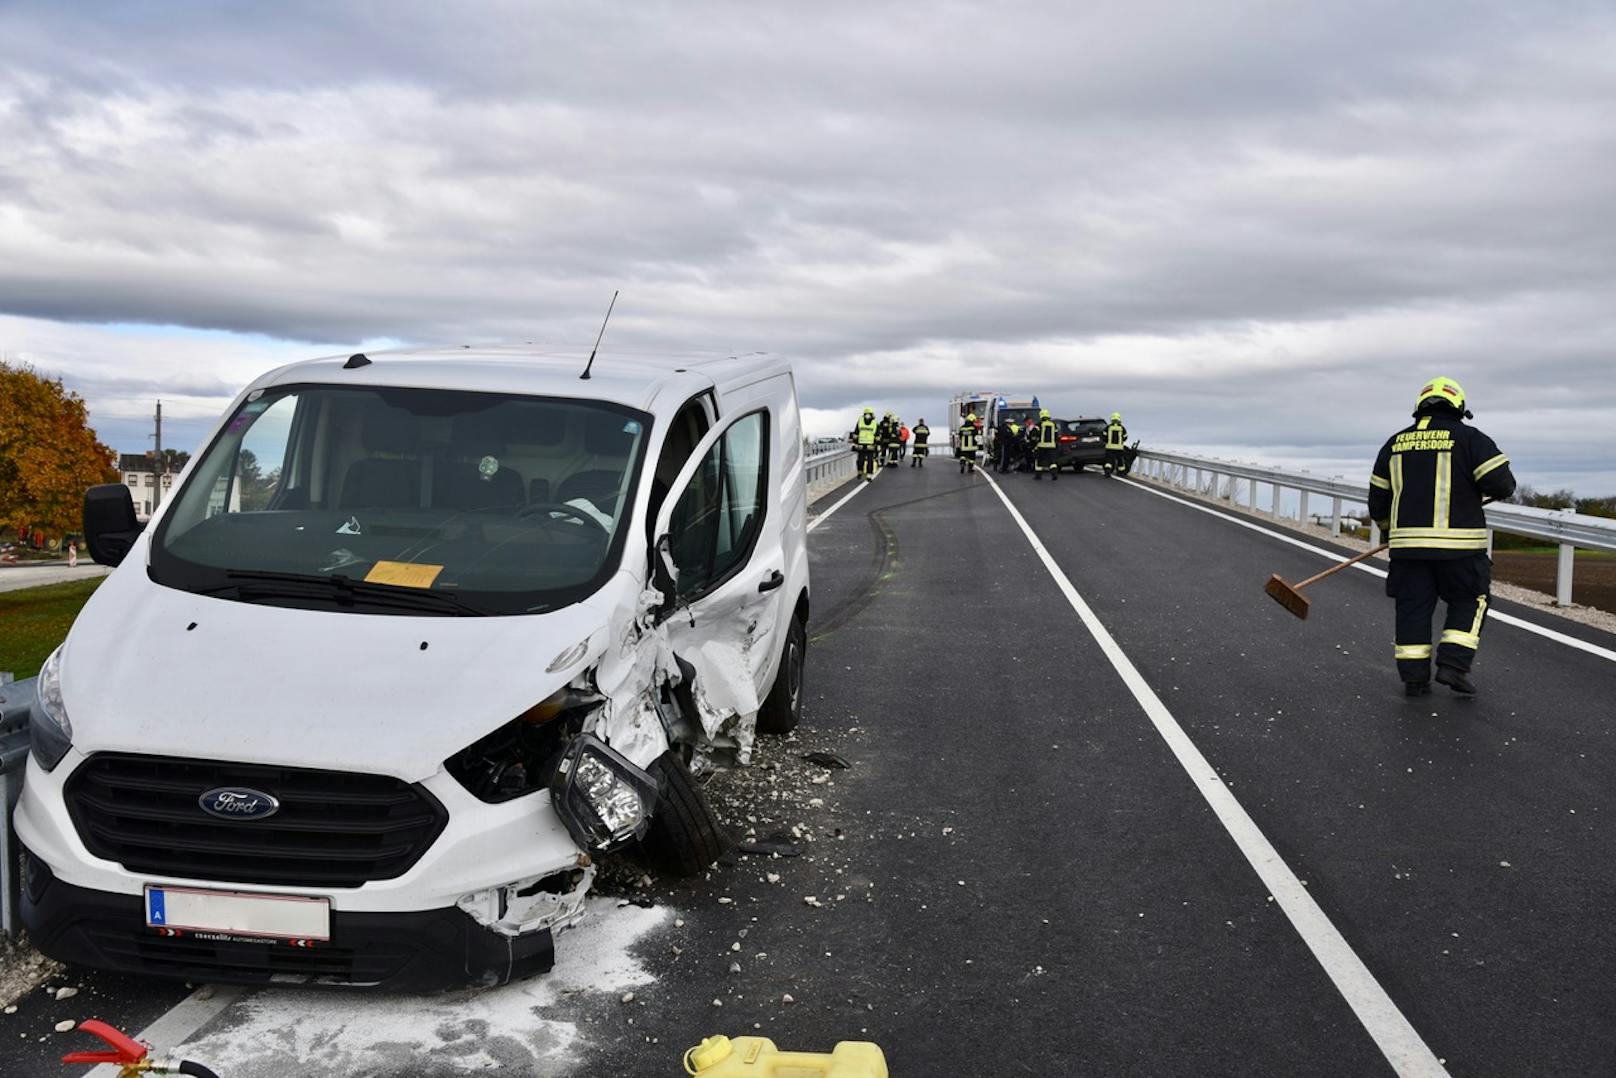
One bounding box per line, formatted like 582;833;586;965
145;886;331;947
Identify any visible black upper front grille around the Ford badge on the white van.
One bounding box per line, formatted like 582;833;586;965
66;753;448;887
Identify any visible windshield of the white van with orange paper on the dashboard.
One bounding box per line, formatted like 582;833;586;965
152;386;651;614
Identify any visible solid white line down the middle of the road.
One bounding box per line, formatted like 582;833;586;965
983;475;1450;1078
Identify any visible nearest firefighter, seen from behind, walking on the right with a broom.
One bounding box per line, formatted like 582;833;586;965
1369;378;1516;697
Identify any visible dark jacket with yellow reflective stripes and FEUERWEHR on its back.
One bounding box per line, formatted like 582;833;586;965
1369;412;1514;558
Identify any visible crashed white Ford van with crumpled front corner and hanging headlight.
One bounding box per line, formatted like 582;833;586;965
16;349;808;986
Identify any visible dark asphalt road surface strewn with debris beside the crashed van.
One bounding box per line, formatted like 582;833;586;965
0;459;1616;1078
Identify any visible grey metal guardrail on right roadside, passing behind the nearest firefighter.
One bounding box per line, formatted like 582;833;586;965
1134;449;1616;606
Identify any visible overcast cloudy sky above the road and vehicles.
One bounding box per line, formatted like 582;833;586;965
0;0;1616;495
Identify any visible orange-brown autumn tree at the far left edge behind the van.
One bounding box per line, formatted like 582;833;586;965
0;360;118;535
